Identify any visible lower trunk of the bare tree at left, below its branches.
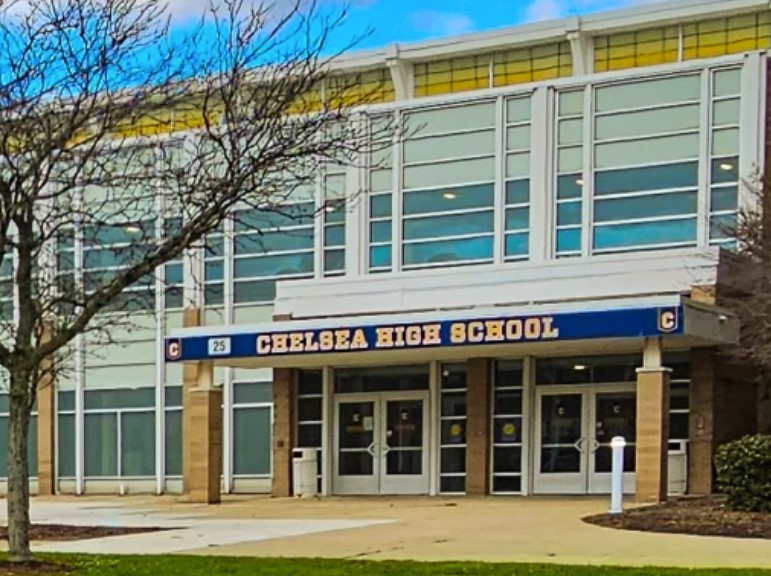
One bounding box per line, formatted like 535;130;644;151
8;373;32;562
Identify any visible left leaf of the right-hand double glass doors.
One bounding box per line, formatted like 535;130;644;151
535;392;586;494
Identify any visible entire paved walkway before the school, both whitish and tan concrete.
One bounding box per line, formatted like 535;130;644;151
6;497;771;568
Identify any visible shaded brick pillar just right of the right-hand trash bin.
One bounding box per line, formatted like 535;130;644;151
688;348;715;494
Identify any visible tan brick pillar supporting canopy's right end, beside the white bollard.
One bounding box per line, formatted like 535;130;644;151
635;366;671;503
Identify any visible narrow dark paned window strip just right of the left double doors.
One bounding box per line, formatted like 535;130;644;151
439;364;468;494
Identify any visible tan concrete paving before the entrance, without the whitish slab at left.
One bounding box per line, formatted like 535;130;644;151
172;497;771;568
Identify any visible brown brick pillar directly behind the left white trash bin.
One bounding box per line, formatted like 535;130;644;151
271;368;295;498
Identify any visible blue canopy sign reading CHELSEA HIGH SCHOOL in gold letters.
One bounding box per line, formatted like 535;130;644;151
165;306;683;362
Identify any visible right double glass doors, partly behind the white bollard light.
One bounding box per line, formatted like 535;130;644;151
534;387;637;494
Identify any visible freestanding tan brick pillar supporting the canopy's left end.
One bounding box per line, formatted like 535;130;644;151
182;308;222;504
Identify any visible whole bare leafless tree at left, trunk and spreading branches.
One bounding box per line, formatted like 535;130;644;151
0;0;394;561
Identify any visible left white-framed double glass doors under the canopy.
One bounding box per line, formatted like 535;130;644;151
333;392;429;494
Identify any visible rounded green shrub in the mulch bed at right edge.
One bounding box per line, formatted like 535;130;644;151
715;434;771;512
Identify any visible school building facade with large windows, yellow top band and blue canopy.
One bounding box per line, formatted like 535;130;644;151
7;0;771;501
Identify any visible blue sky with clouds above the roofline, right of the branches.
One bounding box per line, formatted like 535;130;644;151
170;0;671;49
